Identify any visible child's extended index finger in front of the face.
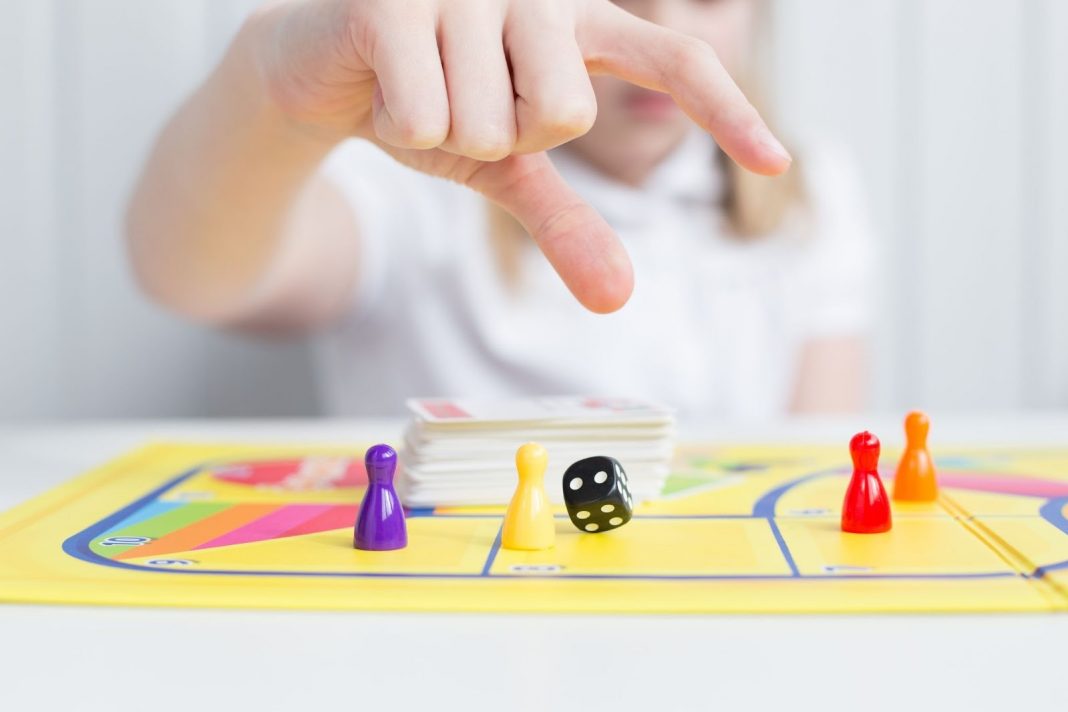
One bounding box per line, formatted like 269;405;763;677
577;0;792;175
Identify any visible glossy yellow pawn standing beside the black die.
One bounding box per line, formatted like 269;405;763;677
501;443;556;551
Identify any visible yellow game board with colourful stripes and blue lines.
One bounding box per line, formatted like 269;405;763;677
0;444;1068;613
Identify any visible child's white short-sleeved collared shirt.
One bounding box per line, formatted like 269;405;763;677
317;131;871;418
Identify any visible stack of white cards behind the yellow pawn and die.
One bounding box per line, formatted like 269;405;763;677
396;396;675;507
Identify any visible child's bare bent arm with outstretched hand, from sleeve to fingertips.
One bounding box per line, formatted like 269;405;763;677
127;0;789;326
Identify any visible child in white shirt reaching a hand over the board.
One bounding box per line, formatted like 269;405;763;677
128;0;869;418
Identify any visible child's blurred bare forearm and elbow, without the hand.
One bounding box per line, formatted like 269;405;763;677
127;7;359;327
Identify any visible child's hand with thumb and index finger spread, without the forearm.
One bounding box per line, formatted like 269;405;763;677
250;0;790;312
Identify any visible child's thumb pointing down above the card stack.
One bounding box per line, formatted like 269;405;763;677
465;153;634;314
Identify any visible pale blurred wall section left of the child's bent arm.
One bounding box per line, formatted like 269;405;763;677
0;0;316;417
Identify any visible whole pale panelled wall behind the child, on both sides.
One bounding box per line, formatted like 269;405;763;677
0;0;1068;417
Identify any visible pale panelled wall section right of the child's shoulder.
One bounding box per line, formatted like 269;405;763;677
776;0;1068;409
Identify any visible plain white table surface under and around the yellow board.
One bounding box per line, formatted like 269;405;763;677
0;413;1068;712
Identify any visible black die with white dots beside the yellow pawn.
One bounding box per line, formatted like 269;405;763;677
564;456;634;533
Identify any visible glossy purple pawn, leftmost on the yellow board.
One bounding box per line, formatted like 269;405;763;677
352;445;408;551
